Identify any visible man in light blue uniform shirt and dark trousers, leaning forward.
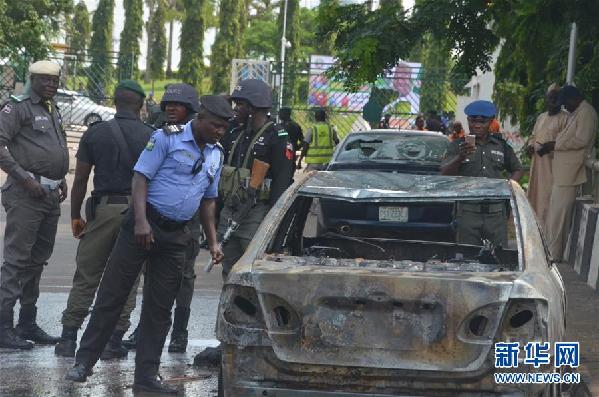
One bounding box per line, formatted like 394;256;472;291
66;96;233;394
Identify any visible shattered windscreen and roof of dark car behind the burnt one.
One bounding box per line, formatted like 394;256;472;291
326;130;450;174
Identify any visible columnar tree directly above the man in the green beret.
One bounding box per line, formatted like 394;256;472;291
118;0;143;80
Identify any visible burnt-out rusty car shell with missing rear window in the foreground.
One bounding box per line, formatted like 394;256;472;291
216;171;565;397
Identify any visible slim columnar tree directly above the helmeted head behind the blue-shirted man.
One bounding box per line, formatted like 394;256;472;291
179;0;206;89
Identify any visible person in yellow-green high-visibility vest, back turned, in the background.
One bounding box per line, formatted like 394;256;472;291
297;108;339;171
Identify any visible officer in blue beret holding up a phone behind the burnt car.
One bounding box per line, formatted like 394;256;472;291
441;100;522;247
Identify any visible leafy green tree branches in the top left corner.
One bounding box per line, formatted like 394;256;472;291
0;0;73;60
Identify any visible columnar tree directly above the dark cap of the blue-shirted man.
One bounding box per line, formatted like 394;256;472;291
210;0;245;92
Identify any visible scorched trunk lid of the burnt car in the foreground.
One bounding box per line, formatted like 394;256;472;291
247;258;521;372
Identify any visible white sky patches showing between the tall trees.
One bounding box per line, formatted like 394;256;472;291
84;0;414;70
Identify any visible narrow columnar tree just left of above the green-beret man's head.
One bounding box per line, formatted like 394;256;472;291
87;0;114;101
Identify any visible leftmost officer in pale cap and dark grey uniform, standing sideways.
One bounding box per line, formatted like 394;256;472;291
0;61;69;349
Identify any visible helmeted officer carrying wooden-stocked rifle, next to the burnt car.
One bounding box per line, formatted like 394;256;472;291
194;79;293;364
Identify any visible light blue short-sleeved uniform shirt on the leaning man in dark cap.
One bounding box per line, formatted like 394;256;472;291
134;122;222;221
